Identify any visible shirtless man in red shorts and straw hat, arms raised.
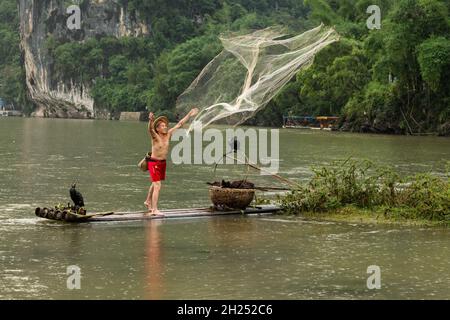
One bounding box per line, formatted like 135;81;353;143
144;108;198;216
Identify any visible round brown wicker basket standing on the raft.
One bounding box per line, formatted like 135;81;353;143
209;187;255;209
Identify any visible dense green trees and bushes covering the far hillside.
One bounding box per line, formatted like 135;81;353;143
0;0;450;135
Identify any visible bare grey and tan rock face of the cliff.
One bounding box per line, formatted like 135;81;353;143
19;0;150;118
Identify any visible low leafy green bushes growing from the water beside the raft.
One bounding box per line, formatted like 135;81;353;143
281;159;450;222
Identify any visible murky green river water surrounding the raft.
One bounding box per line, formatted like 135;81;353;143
0;119;450;299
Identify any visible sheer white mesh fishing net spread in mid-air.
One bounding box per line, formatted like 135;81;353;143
177;25;339;131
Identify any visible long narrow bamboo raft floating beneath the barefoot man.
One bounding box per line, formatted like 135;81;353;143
35;205;281;223
